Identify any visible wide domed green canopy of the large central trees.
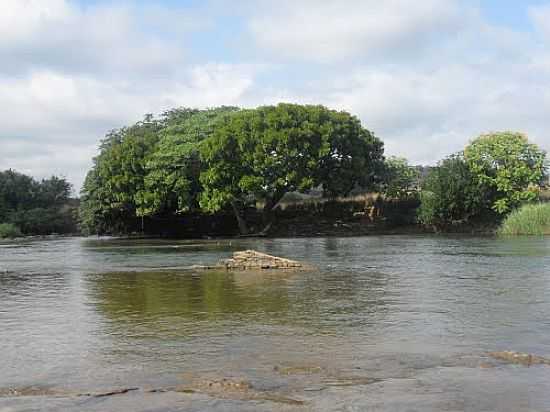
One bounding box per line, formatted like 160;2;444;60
81;104;383;232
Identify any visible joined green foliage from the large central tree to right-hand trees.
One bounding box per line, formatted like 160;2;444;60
76;104;547;234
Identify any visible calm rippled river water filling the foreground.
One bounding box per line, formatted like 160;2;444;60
0;236;550;412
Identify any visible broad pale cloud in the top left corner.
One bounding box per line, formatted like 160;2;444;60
0;0;206;78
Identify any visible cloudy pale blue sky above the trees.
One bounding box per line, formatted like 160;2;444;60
0;0;550;192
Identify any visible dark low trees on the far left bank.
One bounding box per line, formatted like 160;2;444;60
0;169;77;237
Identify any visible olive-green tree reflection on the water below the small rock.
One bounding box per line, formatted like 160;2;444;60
86;271;289;334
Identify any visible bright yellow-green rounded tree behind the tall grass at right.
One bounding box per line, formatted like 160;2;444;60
464;132;546;214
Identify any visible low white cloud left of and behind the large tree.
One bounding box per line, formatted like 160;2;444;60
0;64;260;188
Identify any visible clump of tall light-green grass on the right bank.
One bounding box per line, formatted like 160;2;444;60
499;203;550;235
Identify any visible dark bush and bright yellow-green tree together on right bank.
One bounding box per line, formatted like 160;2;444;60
419;132;547;225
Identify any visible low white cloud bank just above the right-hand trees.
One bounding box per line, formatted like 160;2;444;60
326;61;550;163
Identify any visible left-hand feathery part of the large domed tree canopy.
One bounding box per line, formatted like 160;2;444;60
80;107;236;234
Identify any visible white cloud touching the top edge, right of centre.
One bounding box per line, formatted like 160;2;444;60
250;0;470;62
